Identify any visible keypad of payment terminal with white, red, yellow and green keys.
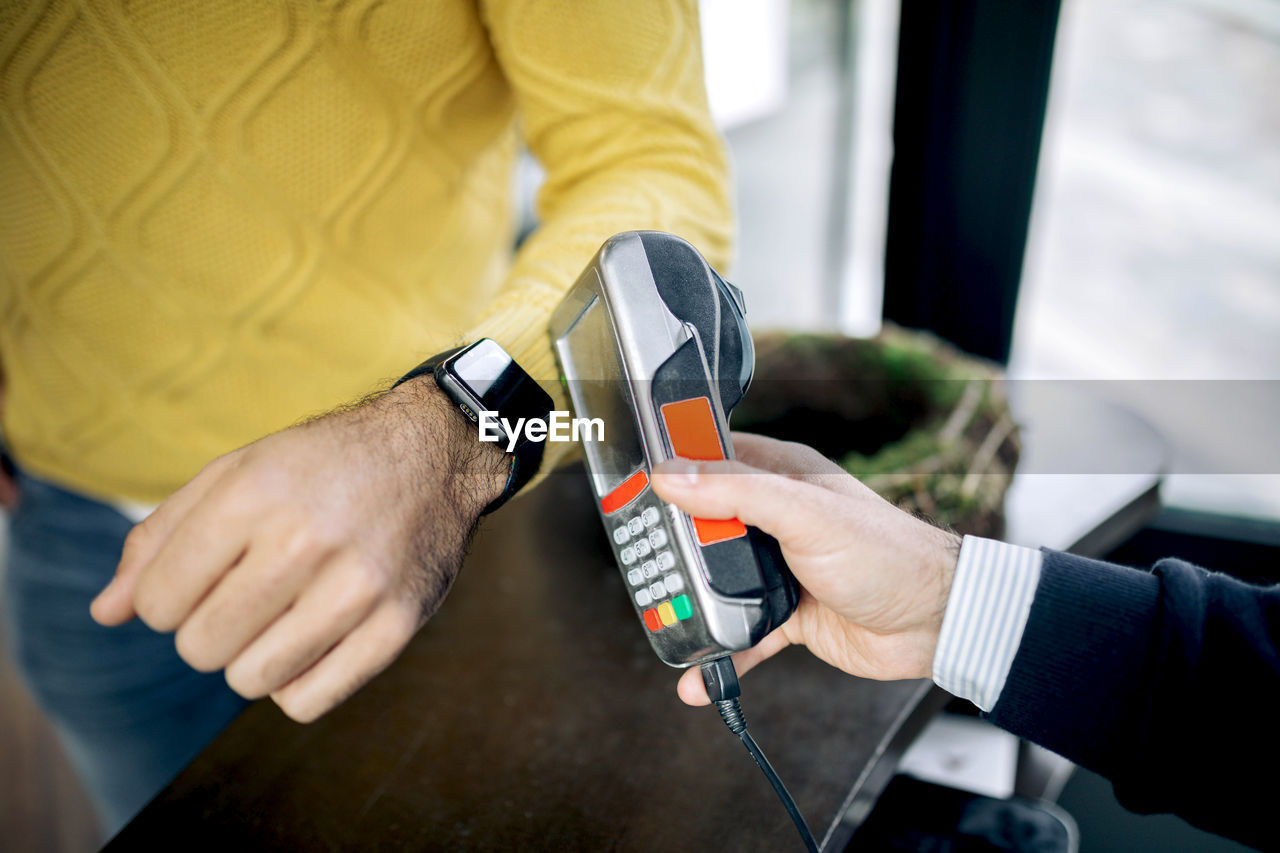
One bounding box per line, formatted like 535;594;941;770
611;500;694;631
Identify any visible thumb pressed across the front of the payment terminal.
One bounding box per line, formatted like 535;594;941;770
653;459;826;547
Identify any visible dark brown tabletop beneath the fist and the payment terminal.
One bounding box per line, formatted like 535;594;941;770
108;469;938;850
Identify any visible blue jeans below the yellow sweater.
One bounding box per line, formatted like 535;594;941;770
3;473;248;835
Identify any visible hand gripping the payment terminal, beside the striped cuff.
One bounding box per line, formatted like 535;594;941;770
653;433;960;704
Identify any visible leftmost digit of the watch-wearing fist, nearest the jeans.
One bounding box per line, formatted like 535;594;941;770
90;456;230;625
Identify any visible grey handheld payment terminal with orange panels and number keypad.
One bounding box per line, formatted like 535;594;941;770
549;232;797;667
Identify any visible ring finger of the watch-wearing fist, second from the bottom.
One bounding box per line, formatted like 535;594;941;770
227;560;381;699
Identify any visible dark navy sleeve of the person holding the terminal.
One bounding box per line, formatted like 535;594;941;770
988;549;1280;849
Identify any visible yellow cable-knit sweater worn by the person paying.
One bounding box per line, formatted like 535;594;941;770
0;0;731;501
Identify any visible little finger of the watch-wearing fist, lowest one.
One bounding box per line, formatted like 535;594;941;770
271;599;421;722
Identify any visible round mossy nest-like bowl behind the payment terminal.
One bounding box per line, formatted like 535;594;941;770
735;327;1018;537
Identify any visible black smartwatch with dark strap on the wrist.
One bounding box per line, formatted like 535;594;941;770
393;338;554;515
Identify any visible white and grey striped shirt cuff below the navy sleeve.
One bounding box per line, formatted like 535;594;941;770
933;537;1042;711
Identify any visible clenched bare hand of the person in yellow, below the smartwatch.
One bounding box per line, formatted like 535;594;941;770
92;378;508;722
